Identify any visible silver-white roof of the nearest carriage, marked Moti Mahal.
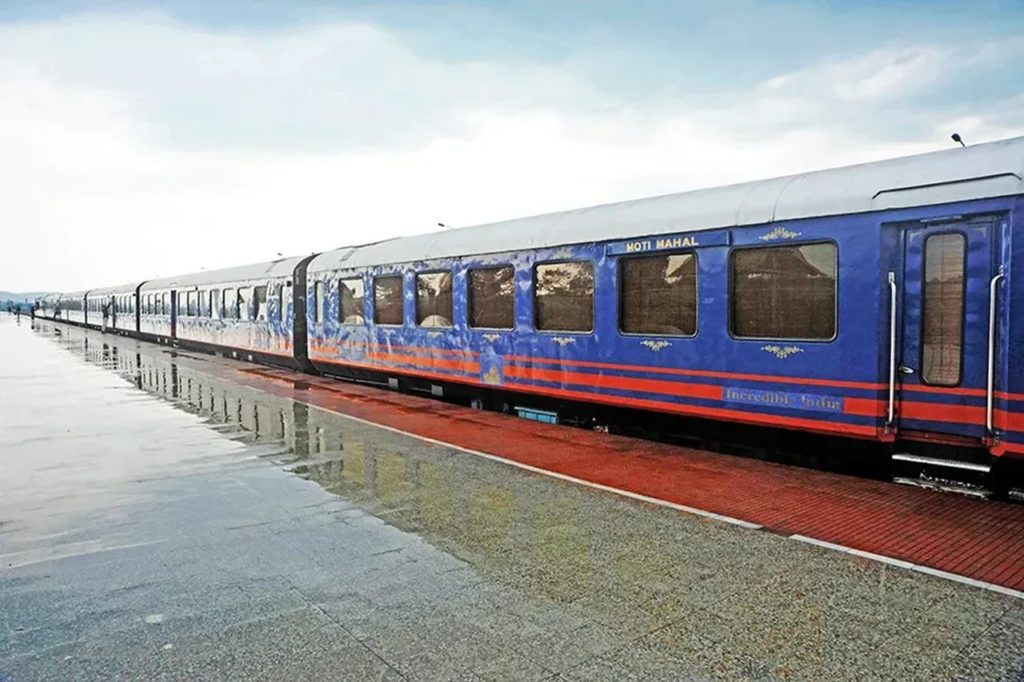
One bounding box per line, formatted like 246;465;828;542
309;137;1024;271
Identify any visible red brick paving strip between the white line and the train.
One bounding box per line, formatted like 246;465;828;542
231;369;1024;590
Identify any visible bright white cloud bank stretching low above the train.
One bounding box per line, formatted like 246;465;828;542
0;16;1012;289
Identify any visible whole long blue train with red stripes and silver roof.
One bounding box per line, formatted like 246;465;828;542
36;137;1024;491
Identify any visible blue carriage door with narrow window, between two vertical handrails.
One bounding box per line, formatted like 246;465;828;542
894;217;1001;443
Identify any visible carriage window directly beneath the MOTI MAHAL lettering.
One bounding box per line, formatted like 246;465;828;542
618;253;697;336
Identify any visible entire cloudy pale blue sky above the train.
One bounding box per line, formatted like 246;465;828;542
0;0;1024;291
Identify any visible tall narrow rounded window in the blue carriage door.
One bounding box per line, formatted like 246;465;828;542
921;232;967;386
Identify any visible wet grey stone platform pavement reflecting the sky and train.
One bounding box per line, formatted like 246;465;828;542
0;314;1024;680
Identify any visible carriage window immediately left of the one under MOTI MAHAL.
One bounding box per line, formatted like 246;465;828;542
534;261;594;332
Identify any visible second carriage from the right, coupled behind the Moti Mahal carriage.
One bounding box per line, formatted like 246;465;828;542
139;258;308;367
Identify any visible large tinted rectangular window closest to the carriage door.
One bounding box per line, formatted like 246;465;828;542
730;244;837;340
